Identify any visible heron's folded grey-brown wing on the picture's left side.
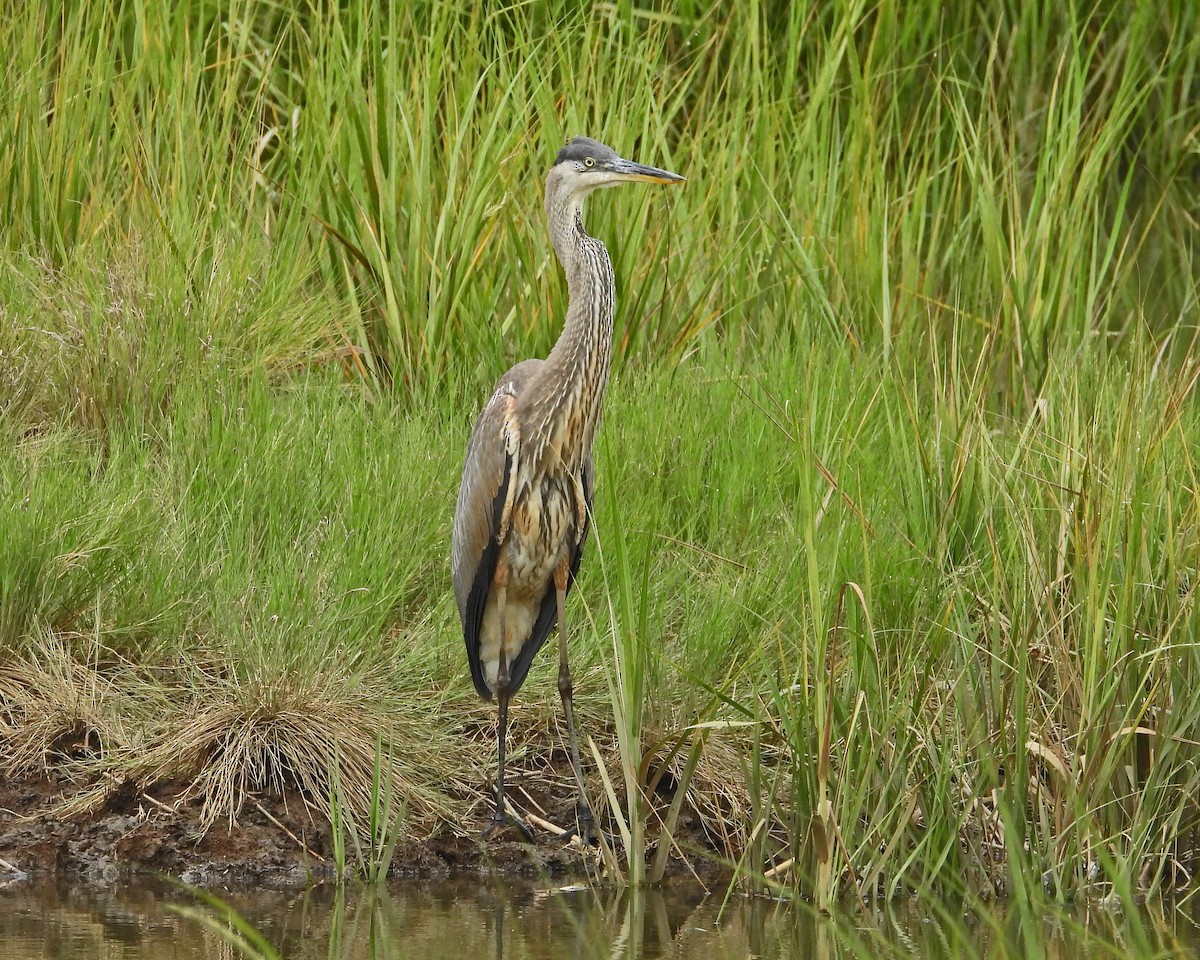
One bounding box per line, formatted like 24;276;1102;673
450;360;540;700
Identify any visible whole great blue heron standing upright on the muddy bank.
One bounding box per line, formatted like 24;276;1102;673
451;137;684;841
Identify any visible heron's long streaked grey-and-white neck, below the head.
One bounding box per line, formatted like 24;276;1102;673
526;169;616;473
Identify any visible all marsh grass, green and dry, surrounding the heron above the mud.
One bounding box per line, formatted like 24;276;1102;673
0;0;1200;906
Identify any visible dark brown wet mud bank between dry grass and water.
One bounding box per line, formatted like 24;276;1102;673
0;773;722;887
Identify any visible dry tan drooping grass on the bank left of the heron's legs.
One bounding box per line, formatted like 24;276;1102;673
0;636;473;834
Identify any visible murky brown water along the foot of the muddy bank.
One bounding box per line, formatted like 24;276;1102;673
0;882;1200;960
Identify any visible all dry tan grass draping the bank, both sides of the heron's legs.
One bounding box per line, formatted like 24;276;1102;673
0;635;746;864
